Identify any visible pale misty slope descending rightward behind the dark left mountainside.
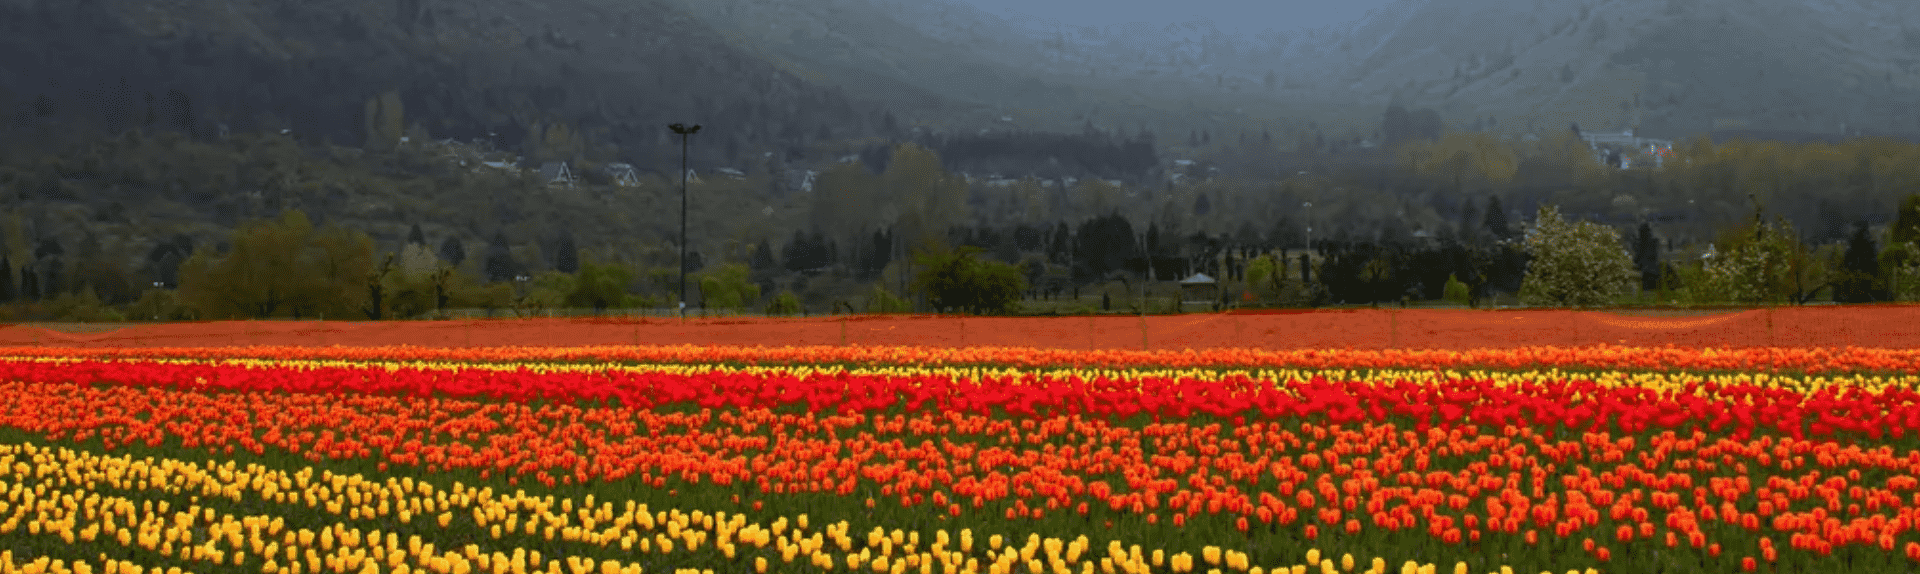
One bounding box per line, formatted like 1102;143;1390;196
645;0;1304;150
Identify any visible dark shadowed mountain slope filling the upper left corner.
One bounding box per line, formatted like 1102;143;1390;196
0;0;885;165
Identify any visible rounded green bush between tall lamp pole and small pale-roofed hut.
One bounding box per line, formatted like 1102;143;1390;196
914;246;1027;315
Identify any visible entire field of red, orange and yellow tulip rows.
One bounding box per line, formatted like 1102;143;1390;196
0;337;1920;574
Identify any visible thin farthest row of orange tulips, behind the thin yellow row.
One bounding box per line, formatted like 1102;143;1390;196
0;346;1920;374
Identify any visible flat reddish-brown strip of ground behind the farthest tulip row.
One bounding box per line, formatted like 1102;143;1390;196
0;305;1920;349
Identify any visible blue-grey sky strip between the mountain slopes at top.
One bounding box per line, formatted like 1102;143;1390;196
952;0;1388;35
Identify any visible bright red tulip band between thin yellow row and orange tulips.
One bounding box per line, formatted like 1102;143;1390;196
0;361;1920;440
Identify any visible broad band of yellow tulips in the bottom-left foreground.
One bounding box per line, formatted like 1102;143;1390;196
0;443;1589;574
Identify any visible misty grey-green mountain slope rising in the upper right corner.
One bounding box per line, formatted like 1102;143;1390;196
1346;0;1920;136
